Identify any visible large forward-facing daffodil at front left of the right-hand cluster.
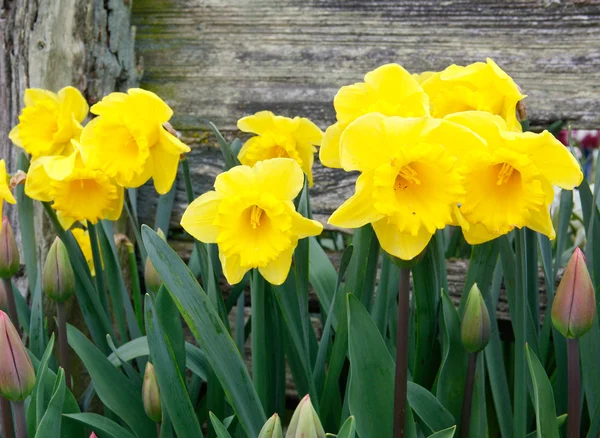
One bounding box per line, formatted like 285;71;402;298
329;113;483;260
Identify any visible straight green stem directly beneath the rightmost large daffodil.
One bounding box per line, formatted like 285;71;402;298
513;229;528;437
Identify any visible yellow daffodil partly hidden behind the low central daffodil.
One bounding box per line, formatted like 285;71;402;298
238;111;323;186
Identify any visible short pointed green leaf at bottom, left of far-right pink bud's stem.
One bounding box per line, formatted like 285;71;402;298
526;347;560;438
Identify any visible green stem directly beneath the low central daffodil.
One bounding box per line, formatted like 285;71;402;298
250;269;268;409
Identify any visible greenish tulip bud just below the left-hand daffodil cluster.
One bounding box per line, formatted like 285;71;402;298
42;237;75;303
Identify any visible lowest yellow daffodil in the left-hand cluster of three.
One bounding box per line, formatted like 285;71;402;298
25;144;123;228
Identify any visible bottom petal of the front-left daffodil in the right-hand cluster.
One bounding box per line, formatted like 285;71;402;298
373;218;433;260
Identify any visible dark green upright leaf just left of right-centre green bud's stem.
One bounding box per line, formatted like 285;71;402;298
436;291;468;420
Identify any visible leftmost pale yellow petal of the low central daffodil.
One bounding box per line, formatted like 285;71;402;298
181;191;221;243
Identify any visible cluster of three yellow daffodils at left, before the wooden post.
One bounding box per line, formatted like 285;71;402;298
9;87;190;228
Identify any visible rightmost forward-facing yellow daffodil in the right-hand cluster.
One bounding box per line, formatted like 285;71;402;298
446;111;583;244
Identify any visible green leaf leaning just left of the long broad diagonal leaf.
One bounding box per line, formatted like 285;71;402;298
144;294;203;437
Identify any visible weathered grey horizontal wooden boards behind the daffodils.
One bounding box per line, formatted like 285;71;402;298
133;0;600;227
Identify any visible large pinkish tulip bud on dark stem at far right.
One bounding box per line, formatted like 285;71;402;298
552;248;596;338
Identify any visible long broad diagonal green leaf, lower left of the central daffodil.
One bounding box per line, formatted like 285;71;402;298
142;226;266;436
